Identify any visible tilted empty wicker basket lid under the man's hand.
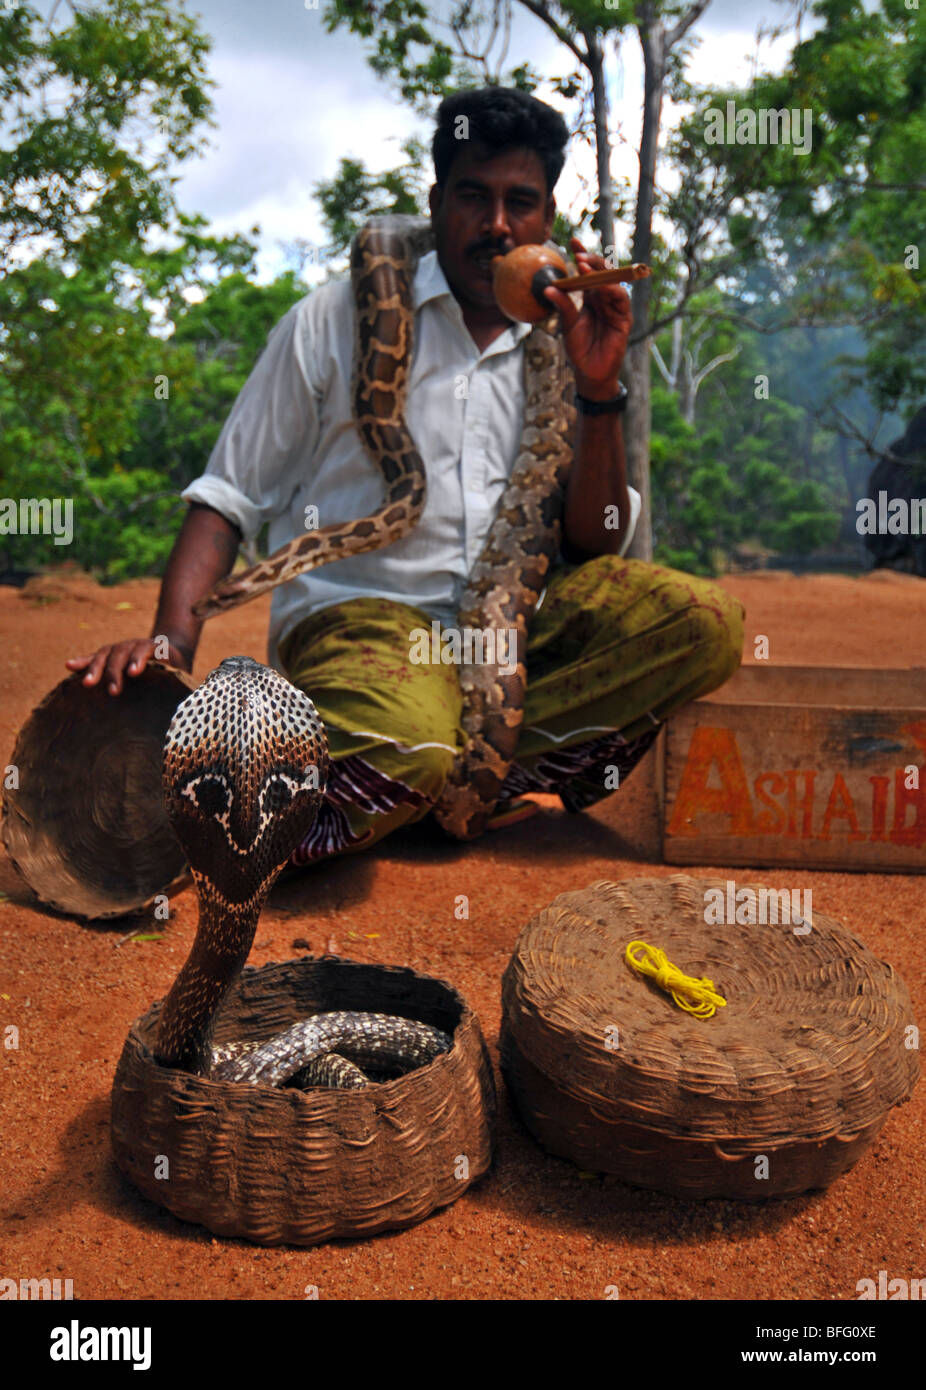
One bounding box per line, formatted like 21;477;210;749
1;662;193;919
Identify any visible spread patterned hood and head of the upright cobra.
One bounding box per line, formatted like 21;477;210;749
163;656;328;905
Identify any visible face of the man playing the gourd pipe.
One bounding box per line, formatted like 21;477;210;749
430;142;555;313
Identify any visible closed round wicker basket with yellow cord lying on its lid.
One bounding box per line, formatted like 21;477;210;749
502;874;919;1200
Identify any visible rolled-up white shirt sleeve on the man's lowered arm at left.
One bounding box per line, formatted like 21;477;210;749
181;300;321;541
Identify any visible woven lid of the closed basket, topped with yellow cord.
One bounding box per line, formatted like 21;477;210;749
503;874;918;1150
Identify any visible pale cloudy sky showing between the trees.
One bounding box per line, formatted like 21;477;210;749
178;0;806;281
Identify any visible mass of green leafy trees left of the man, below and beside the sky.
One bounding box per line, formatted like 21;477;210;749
0;0;303;578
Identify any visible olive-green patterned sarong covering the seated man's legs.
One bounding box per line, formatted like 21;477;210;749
279;555;744;863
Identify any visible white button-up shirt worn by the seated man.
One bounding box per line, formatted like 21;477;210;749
182;252;640;664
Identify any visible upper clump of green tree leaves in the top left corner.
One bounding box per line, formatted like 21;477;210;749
0;0;211;275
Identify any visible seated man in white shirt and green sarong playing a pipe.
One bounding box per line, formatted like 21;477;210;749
68;88;742;862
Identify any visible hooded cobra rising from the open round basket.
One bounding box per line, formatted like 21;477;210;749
154;656;450;1086
